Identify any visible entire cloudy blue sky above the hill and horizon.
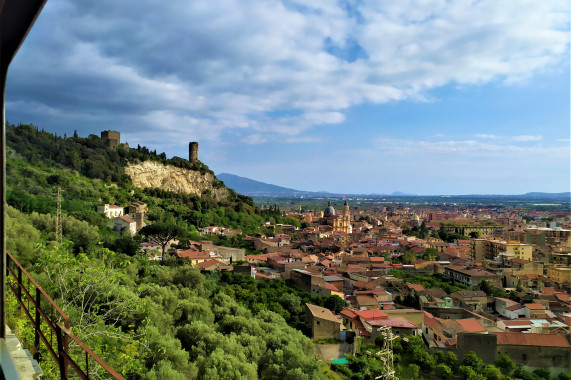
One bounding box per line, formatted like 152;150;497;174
6;0;571;195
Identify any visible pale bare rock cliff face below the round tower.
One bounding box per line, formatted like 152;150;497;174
125;161;228;199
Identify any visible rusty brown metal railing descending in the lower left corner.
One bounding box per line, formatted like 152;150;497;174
6;251;124;380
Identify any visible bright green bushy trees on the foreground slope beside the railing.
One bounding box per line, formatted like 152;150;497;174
7;209;326;379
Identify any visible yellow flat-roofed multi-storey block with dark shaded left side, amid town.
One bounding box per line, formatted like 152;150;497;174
470;239;533;261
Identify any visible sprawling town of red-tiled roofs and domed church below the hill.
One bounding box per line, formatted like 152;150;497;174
99;193;571;374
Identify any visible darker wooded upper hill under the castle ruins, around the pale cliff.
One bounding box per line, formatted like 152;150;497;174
6;125;267;238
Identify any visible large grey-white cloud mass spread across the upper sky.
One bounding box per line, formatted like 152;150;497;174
8;0;569;142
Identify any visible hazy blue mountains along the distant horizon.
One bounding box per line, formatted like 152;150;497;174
216;173;571;201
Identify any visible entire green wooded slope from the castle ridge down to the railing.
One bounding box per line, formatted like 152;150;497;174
5;126;320;380
